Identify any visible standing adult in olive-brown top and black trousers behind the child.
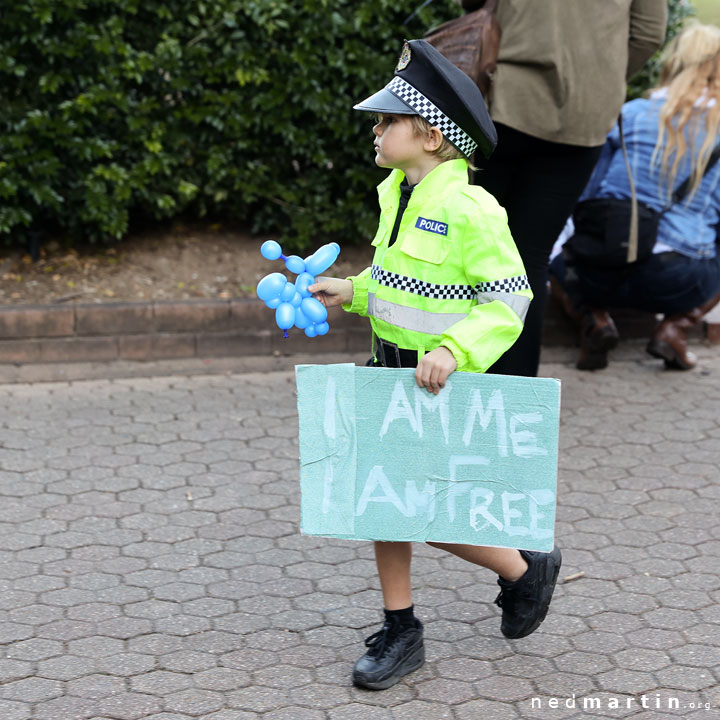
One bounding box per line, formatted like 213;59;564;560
462;0;667;376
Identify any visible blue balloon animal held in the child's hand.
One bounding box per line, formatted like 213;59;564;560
257;240;340;337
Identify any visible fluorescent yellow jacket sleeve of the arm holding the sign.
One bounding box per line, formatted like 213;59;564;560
440;211;532;372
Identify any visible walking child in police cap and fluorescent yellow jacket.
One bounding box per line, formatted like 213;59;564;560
309;40;561;690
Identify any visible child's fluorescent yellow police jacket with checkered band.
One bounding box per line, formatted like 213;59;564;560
343;160;532;372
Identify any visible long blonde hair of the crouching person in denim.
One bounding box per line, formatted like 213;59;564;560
653;23;720;199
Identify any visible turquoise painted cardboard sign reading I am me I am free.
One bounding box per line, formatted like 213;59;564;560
296;364;560;552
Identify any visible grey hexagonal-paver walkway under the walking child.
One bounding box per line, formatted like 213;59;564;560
0;351;720;720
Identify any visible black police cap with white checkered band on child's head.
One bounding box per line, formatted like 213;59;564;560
355;40;497;158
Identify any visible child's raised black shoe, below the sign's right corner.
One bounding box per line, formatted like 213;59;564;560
495;547;562;639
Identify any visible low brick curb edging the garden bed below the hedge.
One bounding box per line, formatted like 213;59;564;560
0;298;720;365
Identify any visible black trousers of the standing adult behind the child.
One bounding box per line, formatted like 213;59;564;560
475;124;602;377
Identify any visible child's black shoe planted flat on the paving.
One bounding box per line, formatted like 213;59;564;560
352;619;425;690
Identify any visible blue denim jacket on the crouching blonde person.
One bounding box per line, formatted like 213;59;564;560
581;97;720;259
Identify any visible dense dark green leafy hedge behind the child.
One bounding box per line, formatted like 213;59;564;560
0;0;460;247
